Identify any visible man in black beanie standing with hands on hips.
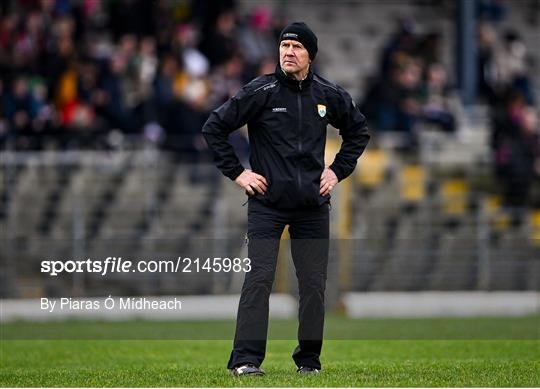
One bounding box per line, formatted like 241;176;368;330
203;23;369;375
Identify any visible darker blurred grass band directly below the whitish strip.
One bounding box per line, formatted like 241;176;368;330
0;315;540;340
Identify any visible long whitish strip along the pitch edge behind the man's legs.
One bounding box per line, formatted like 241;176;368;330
0;292;540;322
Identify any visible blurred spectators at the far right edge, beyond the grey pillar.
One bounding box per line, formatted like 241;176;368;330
477;0;540;207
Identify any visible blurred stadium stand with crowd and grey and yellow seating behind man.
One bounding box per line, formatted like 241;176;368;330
0;0;540;297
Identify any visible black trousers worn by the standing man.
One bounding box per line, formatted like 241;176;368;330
228;199;330;369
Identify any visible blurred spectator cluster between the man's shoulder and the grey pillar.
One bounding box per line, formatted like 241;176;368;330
361;19;456;142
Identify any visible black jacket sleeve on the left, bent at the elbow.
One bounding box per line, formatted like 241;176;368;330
202;84;258;181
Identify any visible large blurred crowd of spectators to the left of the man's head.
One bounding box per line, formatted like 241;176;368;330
0;0;285;155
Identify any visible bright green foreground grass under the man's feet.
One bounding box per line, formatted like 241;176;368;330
0;319;540;387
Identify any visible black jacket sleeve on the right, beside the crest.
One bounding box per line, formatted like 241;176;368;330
330;88;370;181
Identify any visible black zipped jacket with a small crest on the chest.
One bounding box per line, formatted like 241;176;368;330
202;66;369;209
